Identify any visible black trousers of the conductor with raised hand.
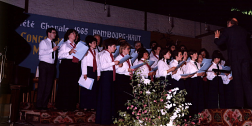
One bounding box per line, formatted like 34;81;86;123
231;60;252;108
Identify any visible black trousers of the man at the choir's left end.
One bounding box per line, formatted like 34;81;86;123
37;61;55;108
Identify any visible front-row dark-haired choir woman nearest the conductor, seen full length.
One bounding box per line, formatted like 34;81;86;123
207;52;226;109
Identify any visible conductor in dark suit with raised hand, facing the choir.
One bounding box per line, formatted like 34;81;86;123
214;18;252;108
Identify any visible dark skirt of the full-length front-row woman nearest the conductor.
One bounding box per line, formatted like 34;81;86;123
207;76;225;109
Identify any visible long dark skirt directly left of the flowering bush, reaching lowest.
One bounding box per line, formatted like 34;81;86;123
95;71;115;125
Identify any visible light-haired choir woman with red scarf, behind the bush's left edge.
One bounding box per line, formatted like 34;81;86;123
115;42;134;116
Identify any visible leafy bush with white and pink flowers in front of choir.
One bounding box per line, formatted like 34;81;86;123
114;72;198;126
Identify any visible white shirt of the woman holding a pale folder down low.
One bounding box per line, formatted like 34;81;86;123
81;49;101;76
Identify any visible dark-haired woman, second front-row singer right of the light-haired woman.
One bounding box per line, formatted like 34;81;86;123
156;49;177;90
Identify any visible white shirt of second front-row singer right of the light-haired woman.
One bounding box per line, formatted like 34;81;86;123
156;60;172;77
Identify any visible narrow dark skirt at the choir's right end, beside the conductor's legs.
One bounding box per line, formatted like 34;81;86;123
223;80;235;109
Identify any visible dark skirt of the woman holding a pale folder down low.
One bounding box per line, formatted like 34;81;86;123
80;67;98;109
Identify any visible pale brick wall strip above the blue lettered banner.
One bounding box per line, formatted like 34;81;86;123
0;0;227;57
